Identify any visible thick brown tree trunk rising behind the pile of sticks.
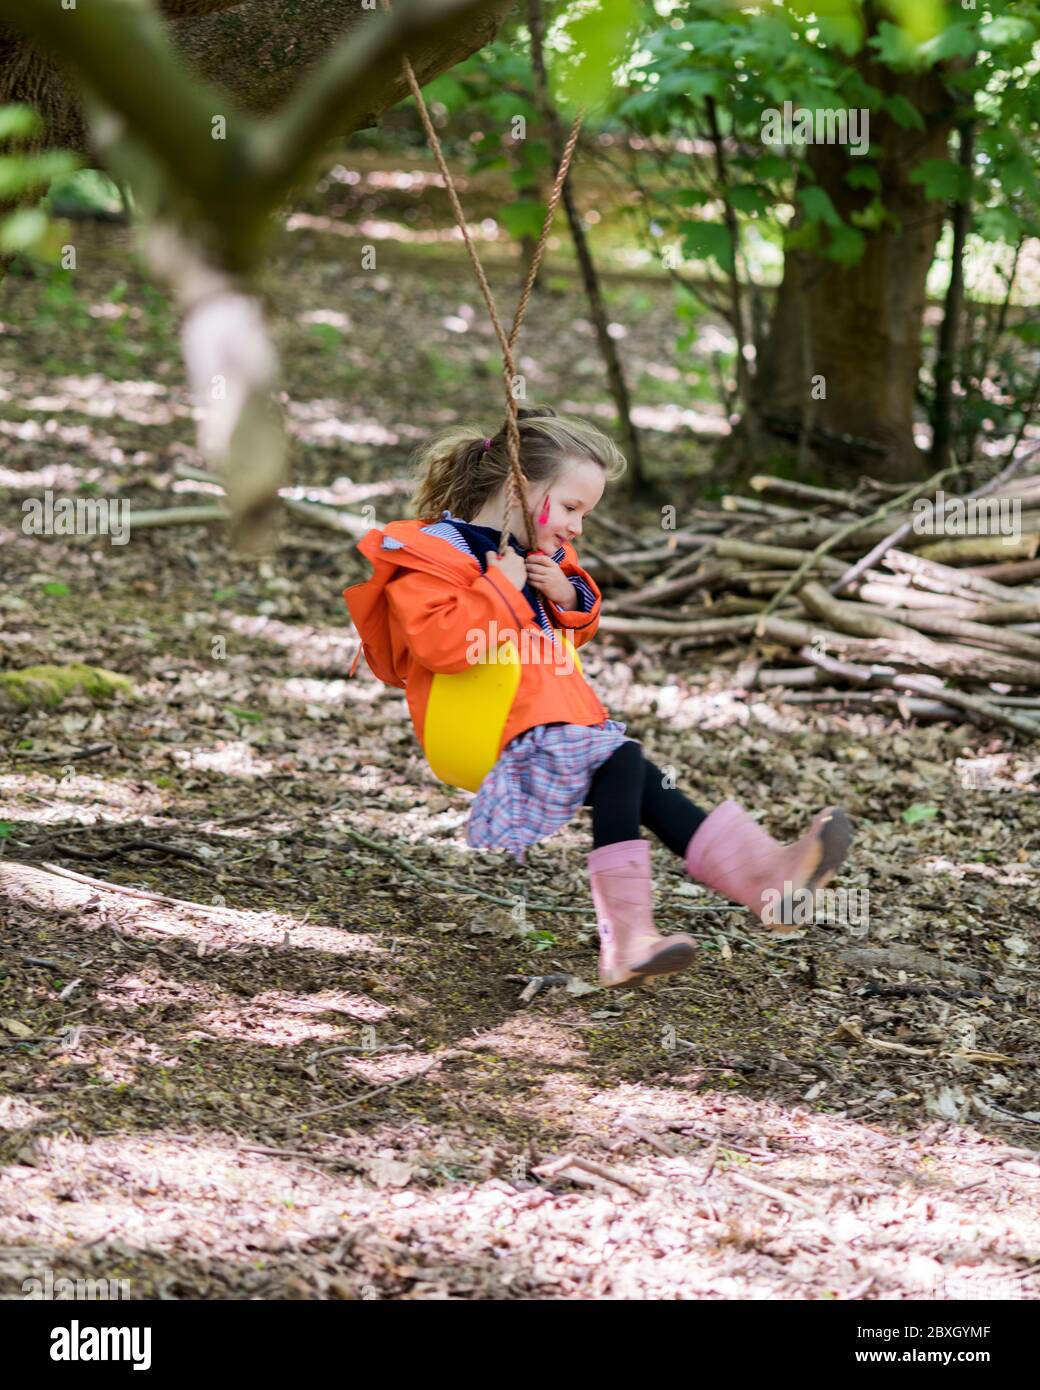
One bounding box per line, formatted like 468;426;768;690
755;42;954;481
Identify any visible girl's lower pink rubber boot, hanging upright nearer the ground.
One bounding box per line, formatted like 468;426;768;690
588;840;697;986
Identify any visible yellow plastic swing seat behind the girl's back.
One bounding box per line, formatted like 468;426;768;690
423;632;581;791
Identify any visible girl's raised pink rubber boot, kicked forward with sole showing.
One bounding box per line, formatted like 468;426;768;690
685;801;852;927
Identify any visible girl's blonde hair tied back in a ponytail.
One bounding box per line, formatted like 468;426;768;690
412;406;626;533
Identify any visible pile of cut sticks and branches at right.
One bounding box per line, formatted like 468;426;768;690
581;461;1040;738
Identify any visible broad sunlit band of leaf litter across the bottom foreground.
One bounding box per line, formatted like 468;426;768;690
0;1089;1040;1300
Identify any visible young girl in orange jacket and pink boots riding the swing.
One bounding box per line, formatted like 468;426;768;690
343;406;850;986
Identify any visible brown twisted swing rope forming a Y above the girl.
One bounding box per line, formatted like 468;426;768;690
382;0;585;559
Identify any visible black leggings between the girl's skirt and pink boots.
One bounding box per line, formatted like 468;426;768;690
585;742;706;856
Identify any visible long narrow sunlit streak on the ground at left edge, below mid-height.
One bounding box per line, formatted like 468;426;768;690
0;859;388;955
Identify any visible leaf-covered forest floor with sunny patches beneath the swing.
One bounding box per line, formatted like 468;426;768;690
0;190;1040;1300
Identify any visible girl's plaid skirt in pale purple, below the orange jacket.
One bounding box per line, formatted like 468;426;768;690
466;719;633;863
